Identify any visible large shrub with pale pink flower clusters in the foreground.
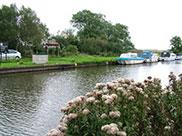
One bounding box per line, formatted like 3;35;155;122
47;73;182;136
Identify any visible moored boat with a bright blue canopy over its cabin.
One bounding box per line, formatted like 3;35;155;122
141;50;159;62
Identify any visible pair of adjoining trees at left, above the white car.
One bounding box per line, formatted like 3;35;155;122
0;4;49;51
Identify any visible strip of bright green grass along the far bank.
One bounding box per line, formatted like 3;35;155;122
0;56;116;68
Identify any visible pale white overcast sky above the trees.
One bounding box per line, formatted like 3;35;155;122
0;0;182;50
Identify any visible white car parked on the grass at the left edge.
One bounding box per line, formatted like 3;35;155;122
0;49;21;60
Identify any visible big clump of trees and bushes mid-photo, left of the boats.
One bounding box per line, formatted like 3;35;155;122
71;10;134;55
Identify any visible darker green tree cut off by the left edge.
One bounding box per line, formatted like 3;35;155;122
0;4;19;49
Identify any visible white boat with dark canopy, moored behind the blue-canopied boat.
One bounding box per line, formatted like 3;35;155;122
160;51;176;61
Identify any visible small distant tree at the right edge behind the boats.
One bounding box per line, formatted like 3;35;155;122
170;36;182;53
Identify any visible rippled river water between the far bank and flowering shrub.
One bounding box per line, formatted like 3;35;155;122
0;61;182;136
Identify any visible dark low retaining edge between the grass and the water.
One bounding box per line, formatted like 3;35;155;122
0;61;118;75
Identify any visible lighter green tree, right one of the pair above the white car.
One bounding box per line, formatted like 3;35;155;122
19;6;49;52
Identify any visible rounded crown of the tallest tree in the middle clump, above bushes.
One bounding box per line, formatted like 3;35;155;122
70;10;105;39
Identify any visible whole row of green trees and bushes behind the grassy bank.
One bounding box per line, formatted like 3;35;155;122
0;4;134;56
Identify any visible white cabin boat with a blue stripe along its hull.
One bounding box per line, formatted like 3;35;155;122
117;53;144;65
